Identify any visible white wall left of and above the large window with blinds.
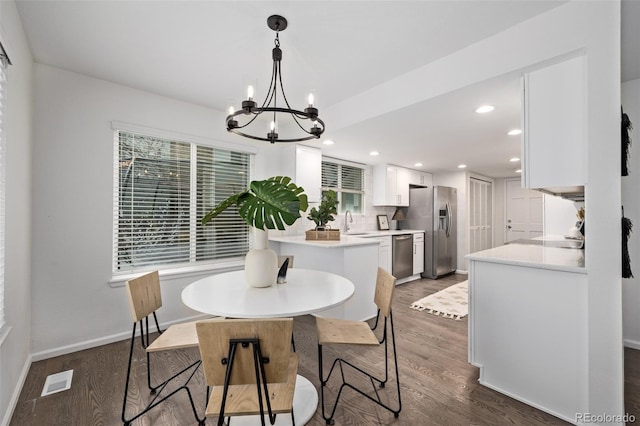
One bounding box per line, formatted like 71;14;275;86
31;64;262;359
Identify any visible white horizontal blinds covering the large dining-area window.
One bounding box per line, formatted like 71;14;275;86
114;131;250;272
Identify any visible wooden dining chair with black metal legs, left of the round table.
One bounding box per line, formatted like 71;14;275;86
122;271;205;425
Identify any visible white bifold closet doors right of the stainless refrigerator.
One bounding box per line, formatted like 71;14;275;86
469;178;493;253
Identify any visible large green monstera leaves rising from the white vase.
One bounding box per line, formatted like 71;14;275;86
202;176;309;231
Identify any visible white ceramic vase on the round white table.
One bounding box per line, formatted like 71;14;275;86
244;228;278;287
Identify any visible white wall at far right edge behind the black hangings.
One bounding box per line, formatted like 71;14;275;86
620;80;640;349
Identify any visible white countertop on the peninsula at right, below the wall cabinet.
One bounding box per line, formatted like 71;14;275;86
465;244;587;274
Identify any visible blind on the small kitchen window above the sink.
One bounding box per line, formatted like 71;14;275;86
322;161;364;214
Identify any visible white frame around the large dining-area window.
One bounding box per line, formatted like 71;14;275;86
109;121;257;280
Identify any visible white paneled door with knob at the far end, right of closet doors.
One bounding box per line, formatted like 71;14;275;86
505;179;544;242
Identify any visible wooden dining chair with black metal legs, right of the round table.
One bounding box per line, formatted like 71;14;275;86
316;268;402;424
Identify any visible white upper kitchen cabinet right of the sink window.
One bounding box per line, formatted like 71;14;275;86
373;164;410;207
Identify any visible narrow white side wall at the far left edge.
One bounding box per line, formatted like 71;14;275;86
0;1;33;424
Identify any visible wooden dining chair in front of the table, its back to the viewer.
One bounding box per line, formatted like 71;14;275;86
196;318;298;426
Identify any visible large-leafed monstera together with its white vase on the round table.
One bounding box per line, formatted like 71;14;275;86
202;176;309;287
